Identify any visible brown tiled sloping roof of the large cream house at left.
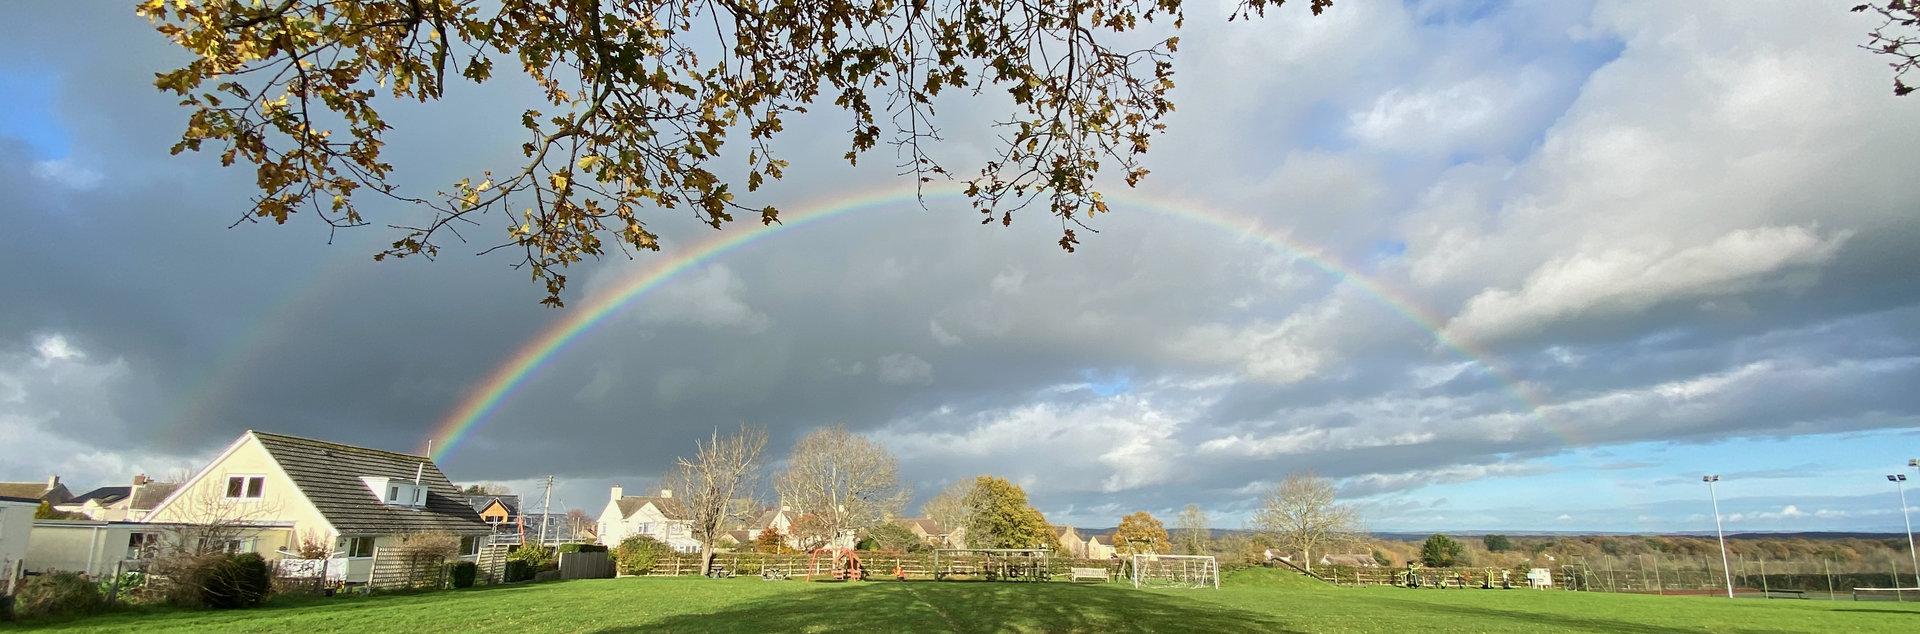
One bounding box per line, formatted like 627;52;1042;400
253;432;493;534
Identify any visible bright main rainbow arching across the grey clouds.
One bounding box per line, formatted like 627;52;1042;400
426;184;1542;459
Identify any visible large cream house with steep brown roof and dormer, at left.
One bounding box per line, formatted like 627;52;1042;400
146;430;493;582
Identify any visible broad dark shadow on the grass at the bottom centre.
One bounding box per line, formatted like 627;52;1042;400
601;582;1288;634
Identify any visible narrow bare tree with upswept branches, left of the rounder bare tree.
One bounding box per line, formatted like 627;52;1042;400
670;425;766;571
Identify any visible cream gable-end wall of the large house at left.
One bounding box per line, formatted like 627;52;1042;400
146;434;336;549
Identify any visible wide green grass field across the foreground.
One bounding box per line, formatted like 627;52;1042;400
7;571;1920;634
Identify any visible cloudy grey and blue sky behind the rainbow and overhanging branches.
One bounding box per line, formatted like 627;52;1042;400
0;2;1920;532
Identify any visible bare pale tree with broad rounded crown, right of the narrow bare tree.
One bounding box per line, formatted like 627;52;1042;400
774;425;906;542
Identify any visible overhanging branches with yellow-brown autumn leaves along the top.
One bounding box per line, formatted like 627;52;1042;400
136;0;1332;305
